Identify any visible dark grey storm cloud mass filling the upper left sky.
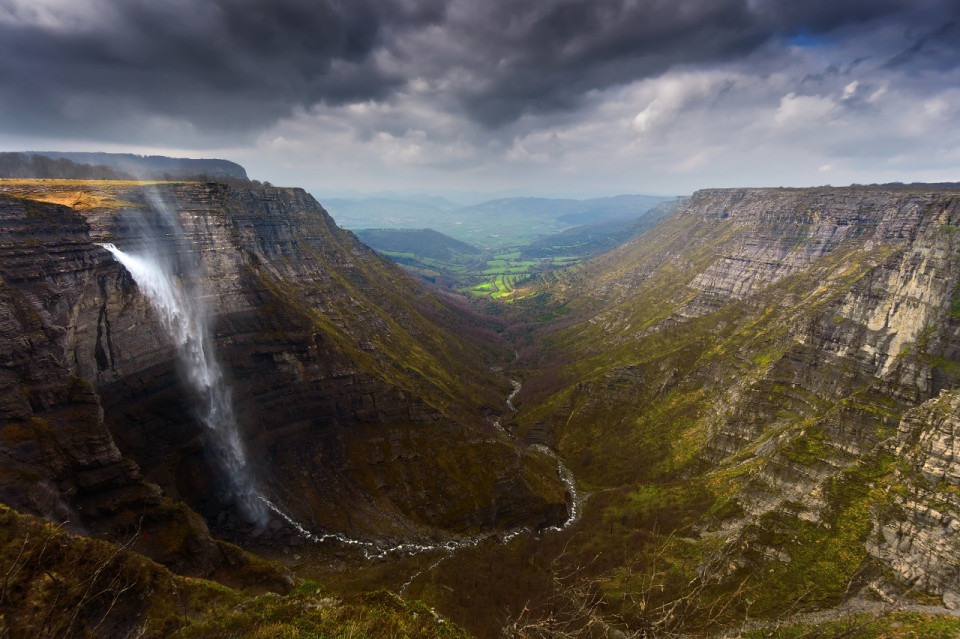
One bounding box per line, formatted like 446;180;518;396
0;0;443;141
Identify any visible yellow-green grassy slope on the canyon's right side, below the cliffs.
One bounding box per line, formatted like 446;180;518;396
476;198;951;636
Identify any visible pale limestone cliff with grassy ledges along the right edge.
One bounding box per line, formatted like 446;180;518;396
700;192;960;608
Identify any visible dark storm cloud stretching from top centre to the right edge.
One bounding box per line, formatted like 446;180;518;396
444;0;958;124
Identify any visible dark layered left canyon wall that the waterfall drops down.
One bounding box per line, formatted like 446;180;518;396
0;184;566;560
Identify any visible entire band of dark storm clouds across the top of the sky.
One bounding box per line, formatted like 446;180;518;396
0;0;960;144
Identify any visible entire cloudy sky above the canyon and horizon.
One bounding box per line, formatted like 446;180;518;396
0;0;960;195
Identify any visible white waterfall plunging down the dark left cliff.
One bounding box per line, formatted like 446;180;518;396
103;238;267;524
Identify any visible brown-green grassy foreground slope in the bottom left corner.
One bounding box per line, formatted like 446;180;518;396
0;505;468;639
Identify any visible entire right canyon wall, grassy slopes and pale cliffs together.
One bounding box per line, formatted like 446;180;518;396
454;187;960;636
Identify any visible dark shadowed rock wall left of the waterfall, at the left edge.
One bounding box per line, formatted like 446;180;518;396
0;195;289;589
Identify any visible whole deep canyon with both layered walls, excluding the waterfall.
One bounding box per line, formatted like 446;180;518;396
0;180;960;637
